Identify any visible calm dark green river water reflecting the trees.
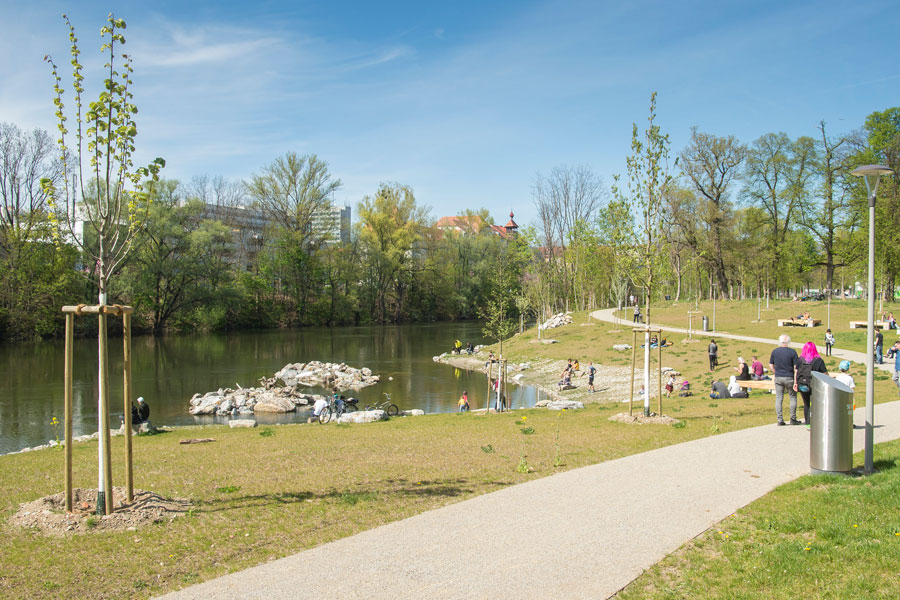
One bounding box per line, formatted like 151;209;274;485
0;323;539;454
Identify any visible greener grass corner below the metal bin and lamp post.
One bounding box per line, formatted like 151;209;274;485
615;441;900;600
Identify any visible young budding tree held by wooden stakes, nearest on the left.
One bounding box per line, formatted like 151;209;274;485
42;13;165;514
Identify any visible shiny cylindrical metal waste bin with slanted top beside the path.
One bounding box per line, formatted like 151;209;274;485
809;372;853;474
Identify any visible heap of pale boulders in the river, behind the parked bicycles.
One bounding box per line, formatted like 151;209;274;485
190;361;380;415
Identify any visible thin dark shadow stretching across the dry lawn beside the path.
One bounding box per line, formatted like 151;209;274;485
195;479;514;513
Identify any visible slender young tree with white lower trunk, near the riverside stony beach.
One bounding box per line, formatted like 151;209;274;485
613;92;678;416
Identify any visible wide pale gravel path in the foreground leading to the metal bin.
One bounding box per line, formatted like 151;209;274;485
158;410;900;600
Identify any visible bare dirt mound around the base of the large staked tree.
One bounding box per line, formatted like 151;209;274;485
9;487;191;535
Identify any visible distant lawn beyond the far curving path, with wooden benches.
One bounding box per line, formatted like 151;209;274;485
619;300;900;354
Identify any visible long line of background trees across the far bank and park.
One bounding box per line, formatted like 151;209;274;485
0;101;900;339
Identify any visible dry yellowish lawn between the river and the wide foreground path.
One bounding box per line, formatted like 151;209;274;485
0;313;896;598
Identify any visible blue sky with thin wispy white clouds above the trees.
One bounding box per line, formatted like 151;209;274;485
0;0;900;224
